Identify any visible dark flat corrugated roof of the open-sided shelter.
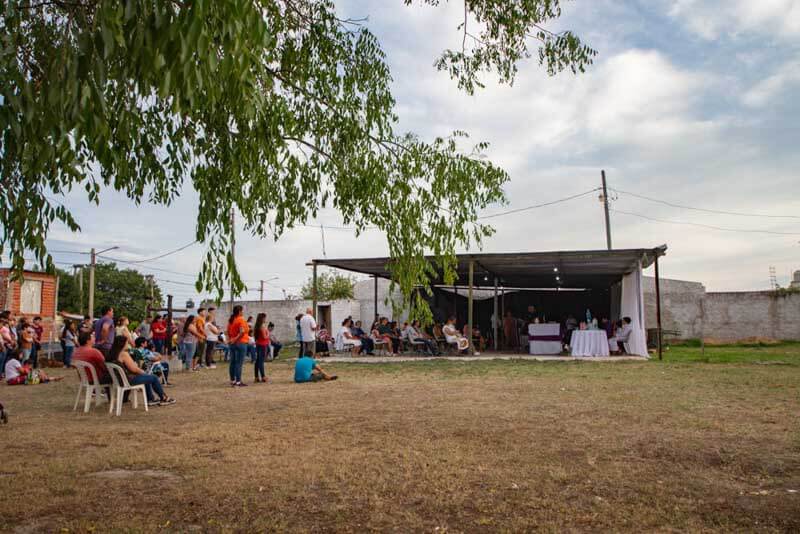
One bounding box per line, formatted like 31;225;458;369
313;245;667;288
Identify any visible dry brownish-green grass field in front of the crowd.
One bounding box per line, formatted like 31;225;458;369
0;346;800;533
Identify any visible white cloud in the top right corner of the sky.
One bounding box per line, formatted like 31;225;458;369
669;0;800;40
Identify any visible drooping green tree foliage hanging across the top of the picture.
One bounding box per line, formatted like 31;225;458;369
0;0;594;322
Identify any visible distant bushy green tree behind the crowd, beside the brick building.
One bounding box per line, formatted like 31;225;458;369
57;263;161;322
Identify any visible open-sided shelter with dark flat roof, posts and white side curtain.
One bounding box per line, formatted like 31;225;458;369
312;245;667;356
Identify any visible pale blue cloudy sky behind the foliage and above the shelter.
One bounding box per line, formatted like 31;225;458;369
34;0;800;299
